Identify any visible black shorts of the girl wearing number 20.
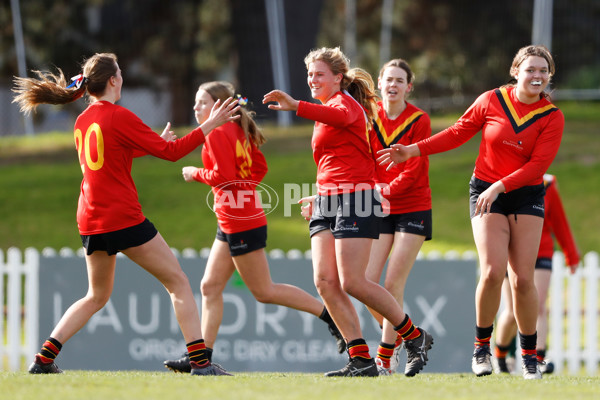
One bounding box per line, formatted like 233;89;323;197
80;218;158;256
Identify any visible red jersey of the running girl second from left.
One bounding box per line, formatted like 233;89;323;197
194;122;267;234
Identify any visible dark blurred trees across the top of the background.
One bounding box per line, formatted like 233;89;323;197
0;0;600;123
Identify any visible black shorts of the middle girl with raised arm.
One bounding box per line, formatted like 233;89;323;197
308;190;383;239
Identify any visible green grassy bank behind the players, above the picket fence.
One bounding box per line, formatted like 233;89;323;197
0;102;600;253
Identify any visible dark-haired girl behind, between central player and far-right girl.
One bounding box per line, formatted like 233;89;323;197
367;58;432;375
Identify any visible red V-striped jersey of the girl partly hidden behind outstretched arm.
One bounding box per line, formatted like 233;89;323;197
370;102;431;214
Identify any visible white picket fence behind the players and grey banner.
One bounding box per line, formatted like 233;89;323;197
0;248;600;375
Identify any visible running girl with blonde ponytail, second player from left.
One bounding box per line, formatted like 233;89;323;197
164;81;346;372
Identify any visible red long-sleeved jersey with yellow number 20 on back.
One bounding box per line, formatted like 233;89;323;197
75;101;204;235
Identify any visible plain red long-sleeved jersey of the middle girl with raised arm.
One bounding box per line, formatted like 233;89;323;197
296;92;375;195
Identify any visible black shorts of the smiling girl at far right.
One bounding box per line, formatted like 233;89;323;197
469;177;546;218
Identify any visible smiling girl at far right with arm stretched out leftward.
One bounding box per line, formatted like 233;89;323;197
378;46;564;379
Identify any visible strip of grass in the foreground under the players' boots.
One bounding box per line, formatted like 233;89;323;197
0;371;600;400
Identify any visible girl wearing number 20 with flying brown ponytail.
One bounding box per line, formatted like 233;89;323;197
13;53;238;375
